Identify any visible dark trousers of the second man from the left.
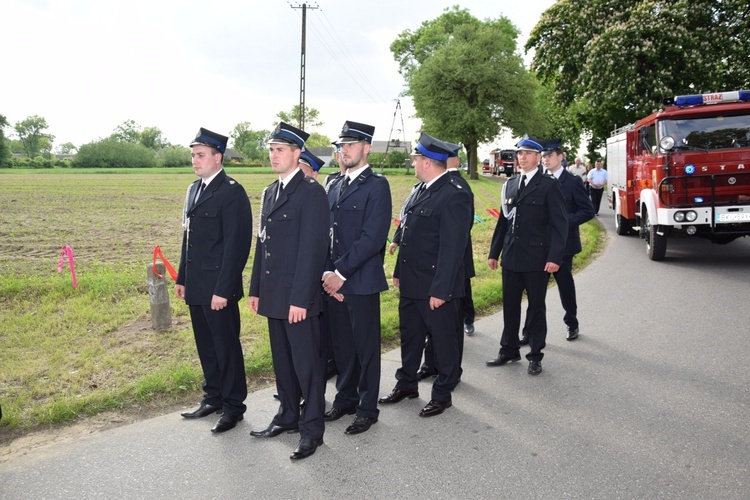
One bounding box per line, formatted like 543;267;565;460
268;316;325;439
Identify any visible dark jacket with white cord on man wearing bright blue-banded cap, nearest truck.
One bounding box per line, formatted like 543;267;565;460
489;168;568;272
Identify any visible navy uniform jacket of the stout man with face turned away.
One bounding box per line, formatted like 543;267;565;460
393;174;471;301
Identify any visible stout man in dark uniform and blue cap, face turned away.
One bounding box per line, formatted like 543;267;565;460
379;134;471;417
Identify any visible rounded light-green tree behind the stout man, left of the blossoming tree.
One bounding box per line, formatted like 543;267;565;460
391;6;543;179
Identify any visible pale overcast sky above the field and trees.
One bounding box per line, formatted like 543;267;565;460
0;0;555;156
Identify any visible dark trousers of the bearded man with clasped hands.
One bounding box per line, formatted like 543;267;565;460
328;293;380;418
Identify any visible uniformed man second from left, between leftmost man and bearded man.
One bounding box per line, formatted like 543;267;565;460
249;122;328;460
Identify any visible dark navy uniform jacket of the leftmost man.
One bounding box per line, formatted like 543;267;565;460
176;169;252;305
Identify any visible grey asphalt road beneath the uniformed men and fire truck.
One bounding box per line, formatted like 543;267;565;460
0;208;750;500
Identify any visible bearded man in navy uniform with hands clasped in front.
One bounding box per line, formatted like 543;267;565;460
323;121;392;434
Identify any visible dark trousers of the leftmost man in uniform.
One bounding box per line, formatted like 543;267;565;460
190;301;247;415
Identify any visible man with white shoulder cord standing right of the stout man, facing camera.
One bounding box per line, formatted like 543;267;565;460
487;136;568;375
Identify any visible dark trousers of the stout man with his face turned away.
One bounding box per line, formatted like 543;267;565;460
396;296;463;401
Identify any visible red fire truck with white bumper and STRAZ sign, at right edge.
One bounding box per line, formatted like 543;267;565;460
607;90;750;260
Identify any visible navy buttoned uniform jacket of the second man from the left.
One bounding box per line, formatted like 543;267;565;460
250;171;328;319
